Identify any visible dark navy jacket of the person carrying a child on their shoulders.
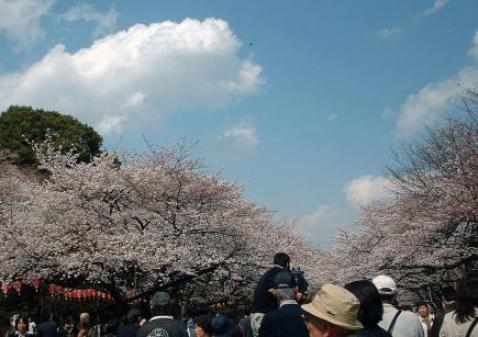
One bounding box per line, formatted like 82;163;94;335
259;304;309;337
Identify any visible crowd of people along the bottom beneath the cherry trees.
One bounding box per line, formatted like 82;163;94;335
5;253;478;337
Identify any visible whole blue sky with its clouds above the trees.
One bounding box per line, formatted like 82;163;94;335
0;0;478;247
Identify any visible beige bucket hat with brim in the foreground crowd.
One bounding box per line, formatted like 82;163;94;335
302;284;363;330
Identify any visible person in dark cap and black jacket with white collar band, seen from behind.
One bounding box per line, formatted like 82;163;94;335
136;292;187;337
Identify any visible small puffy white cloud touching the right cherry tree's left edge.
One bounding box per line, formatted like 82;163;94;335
344;175;391;206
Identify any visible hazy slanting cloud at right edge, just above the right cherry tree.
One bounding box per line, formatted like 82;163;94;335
396;67;478;138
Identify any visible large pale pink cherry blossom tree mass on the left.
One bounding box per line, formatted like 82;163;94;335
0;145;322;299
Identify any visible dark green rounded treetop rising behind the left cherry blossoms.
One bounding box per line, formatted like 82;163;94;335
0;106;103;166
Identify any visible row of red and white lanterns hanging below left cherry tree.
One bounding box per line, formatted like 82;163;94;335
2;278;114;303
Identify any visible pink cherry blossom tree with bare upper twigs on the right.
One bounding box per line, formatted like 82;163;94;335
322;92;478;290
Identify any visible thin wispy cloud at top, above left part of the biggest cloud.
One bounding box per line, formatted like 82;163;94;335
58;3;118;36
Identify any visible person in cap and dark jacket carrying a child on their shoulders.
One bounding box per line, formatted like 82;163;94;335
259;270;309;337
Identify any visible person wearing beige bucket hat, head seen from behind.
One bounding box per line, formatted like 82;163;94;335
302;284;363;337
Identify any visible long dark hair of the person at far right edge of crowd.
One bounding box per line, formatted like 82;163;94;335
455;275;478;323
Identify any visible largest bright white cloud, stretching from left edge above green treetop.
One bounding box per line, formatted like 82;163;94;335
0;18;264;134
